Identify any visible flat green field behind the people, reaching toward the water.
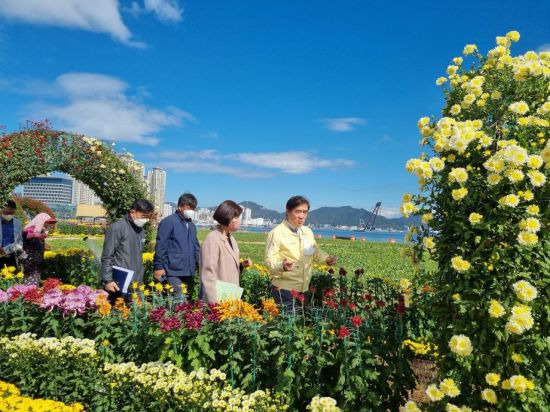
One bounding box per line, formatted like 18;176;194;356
48;230;434;280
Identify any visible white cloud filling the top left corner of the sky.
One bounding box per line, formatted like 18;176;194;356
0;0;144;47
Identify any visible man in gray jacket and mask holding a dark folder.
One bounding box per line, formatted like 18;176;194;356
101;199;155;295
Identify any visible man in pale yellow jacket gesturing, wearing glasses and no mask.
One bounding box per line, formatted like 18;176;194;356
265;196;336;310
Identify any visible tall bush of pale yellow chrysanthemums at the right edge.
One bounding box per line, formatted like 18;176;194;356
402;31;550;411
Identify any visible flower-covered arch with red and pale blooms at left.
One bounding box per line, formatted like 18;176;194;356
0;123;147;221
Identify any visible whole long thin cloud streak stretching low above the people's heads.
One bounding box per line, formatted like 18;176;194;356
145;149;355;178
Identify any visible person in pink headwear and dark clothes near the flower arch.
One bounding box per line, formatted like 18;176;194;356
22;213;57;285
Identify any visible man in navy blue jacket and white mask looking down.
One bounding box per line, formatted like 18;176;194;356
153;193;200;299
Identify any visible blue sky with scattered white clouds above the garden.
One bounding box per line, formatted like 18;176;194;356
0;0;550;217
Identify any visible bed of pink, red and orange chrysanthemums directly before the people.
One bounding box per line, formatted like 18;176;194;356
0;271;414;409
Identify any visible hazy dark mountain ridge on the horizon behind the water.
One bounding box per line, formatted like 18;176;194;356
239;201;421;230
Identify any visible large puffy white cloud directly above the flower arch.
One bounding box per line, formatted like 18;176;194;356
30;73;194;145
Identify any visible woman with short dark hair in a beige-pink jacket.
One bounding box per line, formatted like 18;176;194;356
200;200;252;303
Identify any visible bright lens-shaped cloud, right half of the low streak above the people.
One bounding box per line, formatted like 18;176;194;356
232;151;355;174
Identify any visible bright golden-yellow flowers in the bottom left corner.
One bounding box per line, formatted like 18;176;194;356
0;381;84;412
